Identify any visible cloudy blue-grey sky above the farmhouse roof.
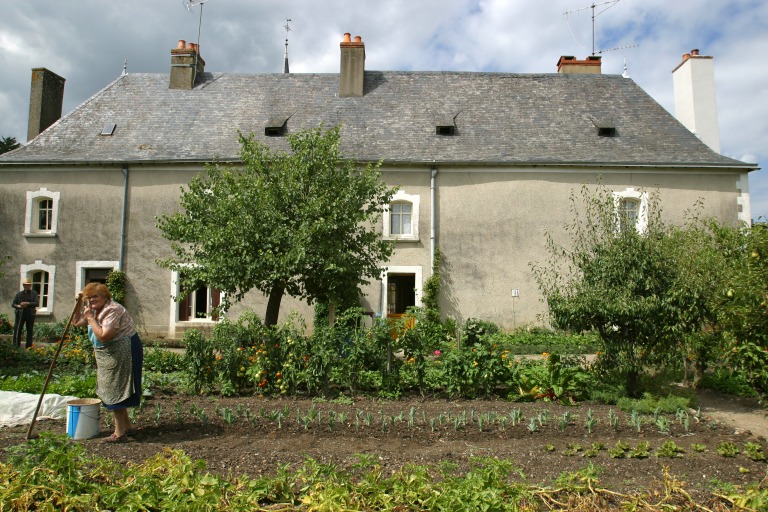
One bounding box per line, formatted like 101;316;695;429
0;0;768;220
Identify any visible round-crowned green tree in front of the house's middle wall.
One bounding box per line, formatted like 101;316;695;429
158;126;395;325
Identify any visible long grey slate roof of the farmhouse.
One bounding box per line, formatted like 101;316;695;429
0;71;755;169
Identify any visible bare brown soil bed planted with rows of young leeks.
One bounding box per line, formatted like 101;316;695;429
0;391;768;499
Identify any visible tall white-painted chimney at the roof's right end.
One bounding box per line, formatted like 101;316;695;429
672;50;720;153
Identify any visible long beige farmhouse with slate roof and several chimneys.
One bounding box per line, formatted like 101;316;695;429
0;34;757;338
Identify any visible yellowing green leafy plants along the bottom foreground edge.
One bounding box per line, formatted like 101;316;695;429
0;433;736;512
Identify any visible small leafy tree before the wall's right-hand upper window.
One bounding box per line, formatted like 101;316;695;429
533;186;677;395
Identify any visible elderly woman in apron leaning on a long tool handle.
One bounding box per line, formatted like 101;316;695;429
72;283;144;443
